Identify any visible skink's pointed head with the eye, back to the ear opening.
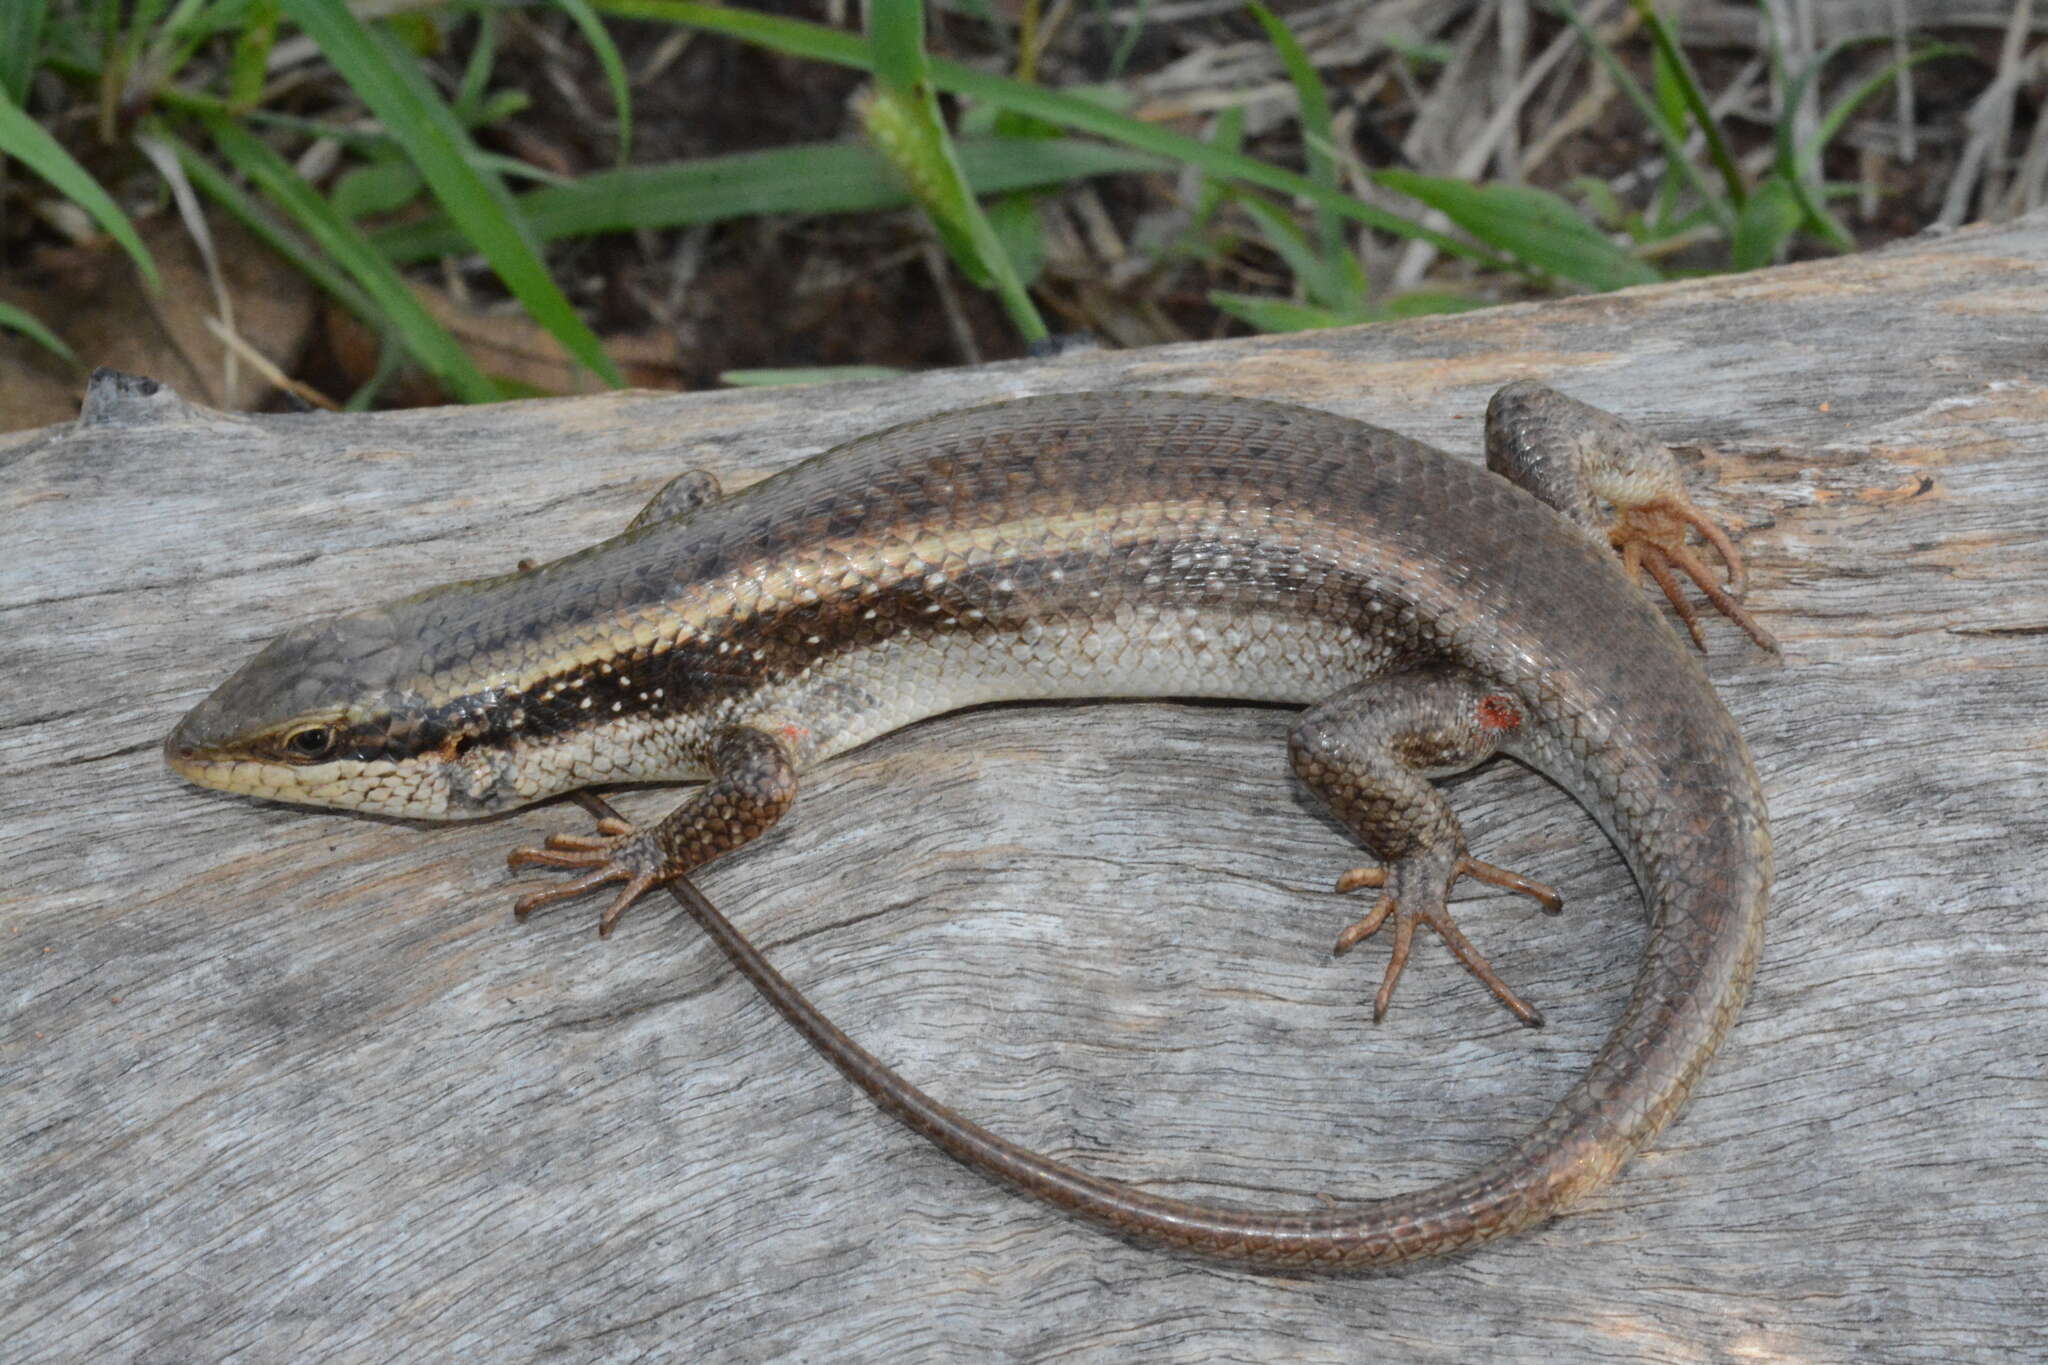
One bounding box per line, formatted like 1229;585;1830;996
164;604;510;821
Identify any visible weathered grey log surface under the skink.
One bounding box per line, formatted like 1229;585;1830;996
0;219;2048;1361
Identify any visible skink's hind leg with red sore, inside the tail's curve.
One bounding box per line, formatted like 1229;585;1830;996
1288;673;1563;1027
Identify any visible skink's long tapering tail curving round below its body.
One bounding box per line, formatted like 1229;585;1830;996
614;757;1772;1271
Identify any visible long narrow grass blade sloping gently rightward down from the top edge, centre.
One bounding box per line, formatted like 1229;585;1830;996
589;0;1505;268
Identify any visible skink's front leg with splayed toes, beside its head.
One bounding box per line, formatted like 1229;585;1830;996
506;724;797;935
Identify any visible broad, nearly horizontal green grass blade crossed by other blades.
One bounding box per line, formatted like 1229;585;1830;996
375;137;1167;262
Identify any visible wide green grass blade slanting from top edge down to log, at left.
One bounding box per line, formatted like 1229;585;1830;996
283;0;625;387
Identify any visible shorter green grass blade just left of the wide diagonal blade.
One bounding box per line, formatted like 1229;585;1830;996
207;119;498;403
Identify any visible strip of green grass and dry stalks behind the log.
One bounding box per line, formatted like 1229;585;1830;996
0;0;2048;428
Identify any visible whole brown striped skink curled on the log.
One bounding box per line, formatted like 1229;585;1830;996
164;383;1772;1269
